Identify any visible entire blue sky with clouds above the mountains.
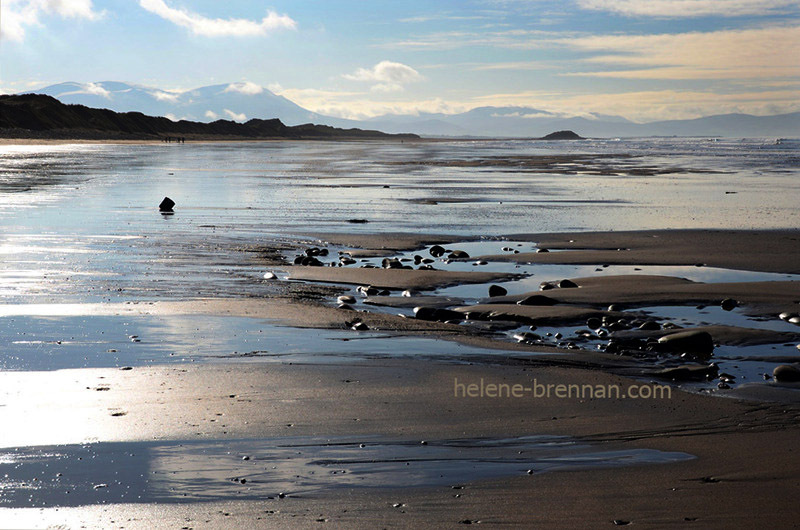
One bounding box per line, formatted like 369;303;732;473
0;0;800;122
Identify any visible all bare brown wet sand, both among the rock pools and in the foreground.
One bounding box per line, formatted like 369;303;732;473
0;227;800;528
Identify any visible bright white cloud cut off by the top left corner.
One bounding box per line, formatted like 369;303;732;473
0;0;103;42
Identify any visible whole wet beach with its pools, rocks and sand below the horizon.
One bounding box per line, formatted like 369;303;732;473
0;142;800;528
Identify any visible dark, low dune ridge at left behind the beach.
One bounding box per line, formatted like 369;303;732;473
0;94;418;140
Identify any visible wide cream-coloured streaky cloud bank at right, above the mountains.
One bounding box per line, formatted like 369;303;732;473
560;26;800;79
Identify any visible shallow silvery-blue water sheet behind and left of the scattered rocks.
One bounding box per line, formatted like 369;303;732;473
0;137;800;378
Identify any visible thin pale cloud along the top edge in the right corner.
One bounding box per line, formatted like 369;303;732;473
578;0;800;18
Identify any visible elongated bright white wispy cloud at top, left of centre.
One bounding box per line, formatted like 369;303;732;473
139;0;297;37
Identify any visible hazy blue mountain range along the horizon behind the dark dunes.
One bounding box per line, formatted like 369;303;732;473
25;81;800;137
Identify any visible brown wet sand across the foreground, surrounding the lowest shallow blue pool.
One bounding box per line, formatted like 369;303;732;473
0;360;800;528
